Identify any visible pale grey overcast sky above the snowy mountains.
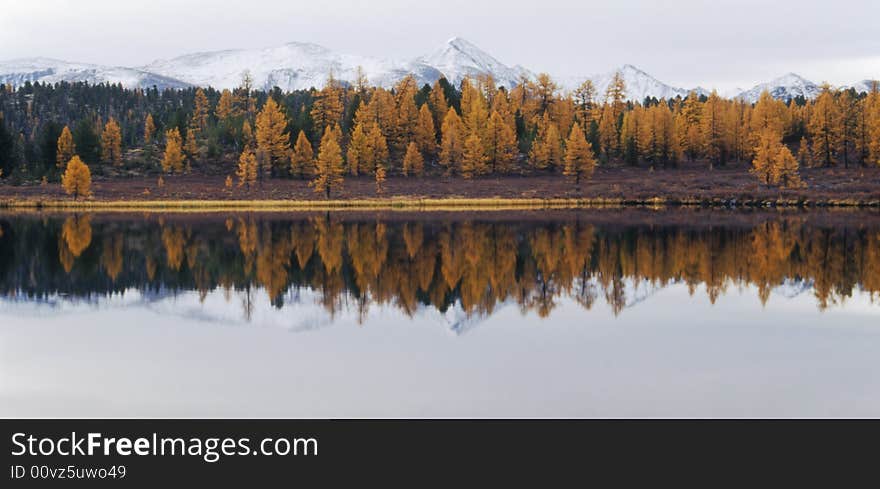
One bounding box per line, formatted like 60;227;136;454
0;0;880;90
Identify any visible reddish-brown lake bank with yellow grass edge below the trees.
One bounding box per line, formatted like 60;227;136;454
0;163;880;210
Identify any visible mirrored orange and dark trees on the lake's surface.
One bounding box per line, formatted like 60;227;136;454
0;211;880;319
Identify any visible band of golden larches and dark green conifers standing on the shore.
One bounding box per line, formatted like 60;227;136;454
0;73;880;195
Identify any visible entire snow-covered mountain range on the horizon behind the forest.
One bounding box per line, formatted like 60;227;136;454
0;37;872;102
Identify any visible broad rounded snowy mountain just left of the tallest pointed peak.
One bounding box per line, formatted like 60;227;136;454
143;42;440;90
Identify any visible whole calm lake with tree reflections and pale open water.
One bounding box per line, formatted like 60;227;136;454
0;209;880;418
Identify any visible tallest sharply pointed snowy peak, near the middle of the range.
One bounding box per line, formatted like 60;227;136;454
415;37;533;88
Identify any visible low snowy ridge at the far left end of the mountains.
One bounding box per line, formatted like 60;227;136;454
0;58;187;89
